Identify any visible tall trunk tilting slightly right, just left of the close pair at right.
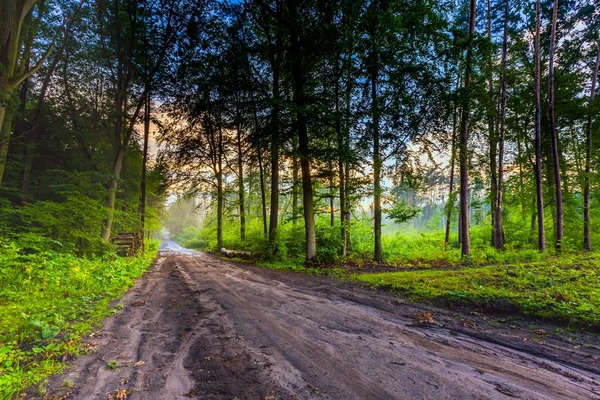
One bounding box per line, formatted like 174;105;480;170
494;0;509;249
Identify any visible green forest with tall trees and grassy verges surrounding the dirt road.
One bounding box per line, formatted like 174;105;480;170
0;0;600;398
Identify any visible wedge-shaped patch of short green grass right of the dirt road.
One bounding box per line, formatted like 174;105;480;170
353;255;600;329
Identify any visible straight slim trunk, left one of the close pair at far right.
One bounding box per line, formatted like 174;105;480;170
534;0;546;251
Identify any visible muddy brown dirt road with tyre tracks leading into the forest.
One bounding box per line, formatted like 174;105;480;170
47;242;600;400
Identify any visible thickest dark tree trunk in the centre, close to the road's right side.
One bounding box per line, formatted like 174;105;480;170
289;10;317;263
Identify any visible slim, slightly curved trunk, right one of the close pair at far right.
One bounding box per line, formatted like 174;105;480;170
548;0;563;252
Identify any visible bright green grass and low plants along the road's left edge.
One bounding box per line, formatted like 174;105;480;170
0;241;158;400
